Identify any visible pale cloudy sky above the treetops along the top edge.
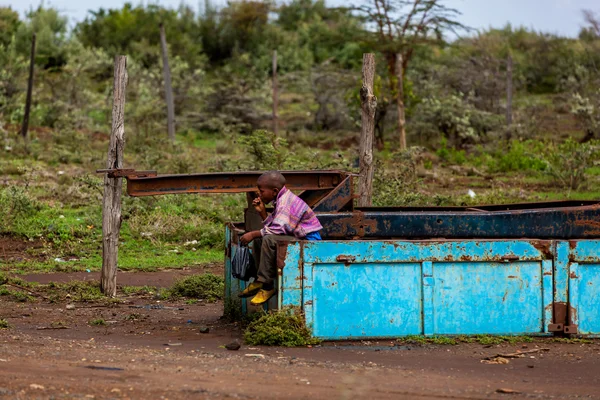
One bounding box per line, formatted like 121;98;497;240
0;0;600;37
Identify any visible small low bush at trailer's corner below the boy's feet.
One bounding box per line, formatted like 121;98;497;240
244;308;320;347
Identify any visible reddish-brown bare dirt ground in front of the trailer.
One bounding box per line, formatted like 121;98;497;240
0;271;600;399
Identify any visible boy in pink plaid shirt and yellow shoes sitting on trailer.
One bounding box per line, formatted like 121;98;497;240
240;171;323;305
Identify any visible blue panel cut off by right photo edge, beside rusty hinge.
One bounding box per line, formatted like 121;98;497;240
569;262;600;334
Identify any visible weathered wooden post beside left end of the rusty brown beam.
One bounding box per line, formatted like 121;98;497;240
100;56;127;296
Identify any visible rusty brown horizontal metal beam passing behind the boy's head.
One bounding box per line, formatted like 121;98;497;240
127;171;346;196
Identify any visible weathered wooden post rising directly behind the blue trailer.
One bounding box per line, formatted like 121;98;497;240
358;53;377;207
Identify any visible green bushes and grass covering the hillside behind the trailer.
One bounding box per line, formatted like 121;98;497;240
0;0;600;278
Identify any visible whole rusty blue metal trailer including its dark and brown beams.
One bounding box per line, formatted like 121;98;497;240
105;170;600;340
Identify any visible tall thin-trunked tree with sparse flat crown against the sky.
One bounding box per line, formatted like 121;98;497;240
354;0;463;147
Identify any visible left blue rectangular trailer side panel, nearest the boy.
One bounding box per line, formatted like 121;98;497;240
312;263;422;339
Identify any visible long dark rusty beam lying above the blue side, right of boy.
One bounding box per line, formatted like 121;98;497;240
319;203;600;239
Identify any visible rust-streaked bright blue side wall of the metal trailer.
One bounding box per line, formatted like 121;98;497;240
226;239;600;340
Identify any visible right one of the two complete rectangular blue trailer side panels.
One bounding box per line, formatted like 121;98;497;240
434;262;544;334
